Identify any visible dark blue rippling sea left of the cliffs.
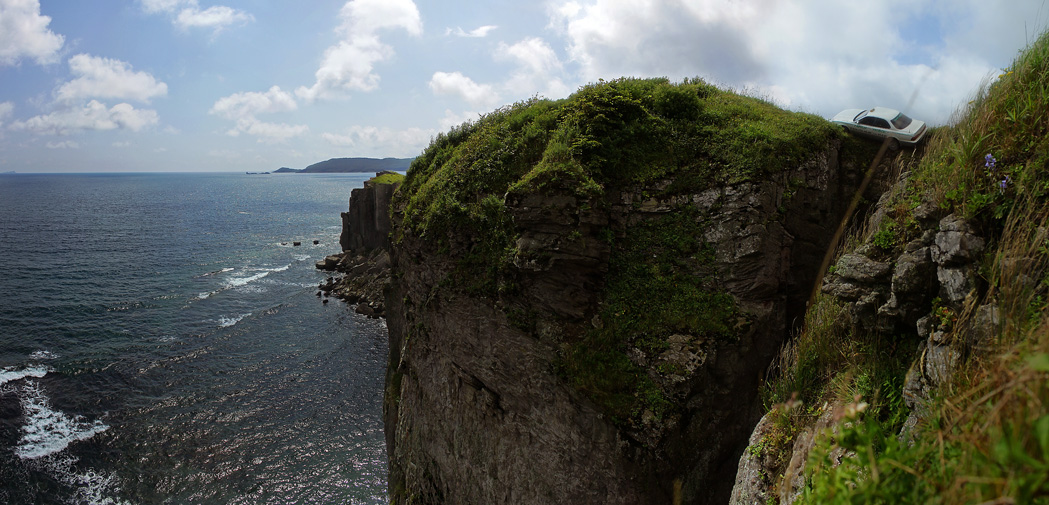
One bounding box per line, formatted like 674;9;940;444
0;173;387;504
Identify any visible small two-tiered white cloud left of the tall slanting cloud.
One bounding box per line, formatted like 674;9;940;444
209;86;309;143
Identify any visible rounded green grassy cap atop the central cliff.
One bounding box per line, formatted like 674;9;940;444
402;79;837;243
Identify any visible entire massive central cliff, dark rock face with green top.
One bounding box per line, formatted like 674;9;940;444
384;76;889;504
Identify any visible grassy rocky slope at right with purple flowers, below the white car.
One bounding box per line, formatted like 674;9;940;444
731;29;1049;504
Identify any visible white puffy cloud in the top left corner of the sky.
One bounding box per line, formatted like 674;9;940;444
0;0;65;65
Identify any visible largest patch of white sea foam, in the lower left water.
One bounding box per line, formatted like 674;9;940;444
15;381;109;460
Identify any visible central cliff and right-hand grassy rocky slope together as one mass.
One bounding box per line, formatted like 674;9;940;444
327;42;1049;495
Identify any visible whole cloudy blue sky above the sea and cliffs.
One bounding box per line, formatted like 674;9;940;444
0;0;1049;172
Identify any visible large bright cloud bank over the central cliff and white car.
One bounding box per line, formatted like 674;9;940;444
545;0;1049;123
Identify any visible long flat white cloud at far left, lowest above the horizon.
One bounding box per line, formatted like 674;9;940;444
10;100;157;134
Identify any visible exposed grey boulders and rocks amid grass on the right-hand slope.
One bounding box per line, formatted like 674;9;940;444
731;174;1001;497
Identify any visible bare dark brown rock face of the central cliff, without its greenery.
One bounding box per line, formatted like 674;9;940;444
384;138;892;504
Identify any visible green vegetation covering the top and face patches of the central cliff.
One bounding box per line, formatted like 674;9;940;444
394;79;841;421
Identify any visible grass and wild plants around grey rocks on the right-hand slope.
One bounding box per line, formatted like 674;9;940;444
766;28;1049;504
